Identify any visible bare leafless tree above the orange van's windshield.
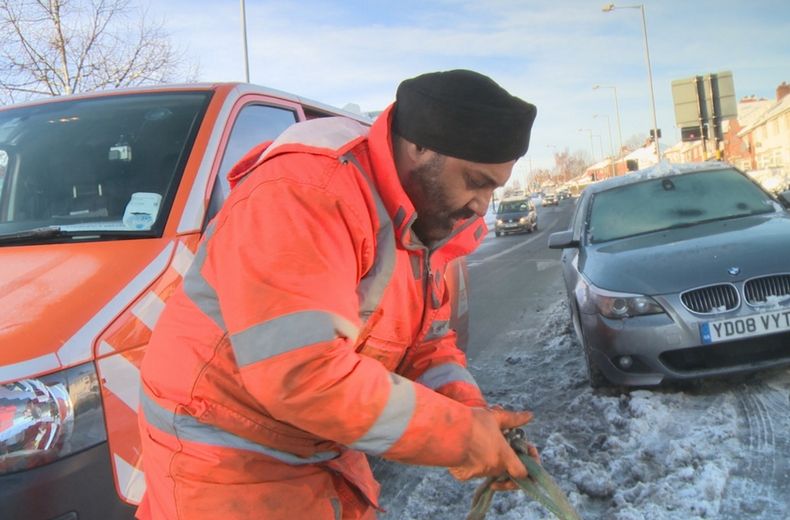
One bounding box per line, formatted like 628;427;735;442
0;0;190;102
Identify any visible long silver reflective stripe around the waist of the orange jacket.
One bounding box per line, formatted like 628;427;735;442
140;391;340;465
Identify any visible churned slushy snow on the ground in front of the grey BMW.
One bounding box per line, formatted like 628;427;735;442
380;302;790;520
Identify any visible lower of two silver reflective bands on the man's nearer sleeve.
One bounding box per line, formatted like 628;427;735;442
349;373;417;455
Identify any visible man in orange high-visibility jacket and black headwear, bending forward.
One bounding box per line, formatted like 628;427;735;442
137;70;536;520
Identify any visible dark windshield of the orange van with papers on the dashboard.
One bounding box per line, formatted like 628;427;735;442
0;92;210;241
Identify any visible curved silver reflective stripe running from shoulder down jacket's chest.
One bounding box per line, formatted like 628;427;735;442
340;153;395;323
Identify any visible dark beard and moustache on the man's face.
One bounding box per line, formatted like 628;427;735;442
407;155;475;245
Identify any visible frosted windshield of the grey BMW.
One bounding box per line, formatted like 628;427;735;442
587;169;779;243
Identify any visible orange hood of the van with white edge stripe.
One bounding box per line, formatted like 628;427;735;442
0;239;174;382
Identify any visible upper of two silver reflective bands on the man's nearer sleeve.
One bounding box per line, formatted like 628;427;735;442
230;311;359;368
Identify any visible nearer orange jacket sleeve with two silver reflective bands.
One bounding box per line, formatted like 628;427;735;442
202;154;480;466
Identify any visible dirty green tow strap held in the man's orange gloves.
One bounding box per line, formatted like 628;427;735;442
466;429;581;520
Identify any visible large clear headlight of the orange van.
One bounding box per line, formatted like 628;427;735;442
0;363;107;475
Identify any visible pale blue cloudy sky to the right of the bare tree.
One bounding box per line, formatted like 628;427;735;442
149;0;790;185
